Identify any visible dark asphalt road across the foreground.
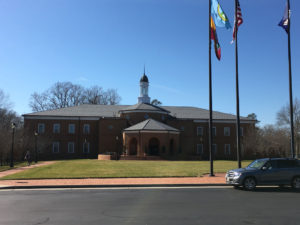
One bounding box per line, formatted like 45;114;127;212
0;187;300;225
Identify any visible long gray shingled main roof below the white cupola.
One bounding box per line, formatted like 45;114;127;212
23;103;254;122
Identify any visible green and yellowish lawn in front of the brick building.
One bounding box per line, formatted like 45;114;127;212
1;159;250;180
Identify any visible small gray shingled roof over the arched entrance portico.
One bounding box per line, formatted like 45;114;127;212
124;119;179;132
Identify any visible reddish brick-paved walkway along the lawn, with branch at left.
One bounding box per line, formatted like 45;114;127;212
0;162;225;188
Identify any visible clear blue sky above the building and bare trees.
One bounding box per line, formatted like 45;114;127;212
0;0;300;125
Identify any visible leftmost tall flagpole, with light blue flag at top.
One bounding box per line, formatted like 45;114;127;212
208;0;214;176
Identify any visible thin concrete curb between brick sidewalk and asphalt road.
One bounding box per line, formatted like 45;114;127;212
0;183;231;190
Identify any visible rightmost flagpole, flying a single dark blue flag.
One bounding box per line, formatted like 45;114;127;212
287;0;295;158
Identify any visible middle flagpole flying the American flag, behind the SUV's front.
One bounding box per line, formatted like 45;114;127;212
234;0;242;168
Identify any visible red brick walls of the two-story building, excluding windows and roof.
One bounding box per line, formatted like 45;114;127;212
24;113;254;159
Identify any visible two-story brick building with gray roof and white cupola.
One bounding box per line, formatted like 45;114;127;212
23;74;256;159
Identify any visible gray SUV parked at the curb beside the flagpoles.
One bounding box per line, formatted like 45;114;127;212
225;158;300;190
